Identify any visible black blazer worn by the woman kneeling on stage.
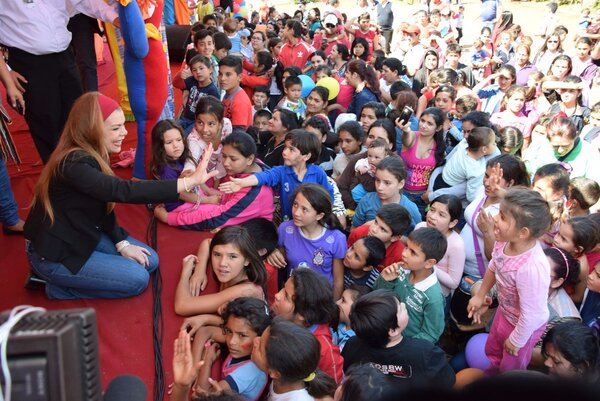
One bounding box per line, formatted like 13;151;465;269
25;151;179;274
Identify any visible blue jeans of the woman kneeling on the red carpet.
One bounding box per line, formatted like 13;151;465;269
25;234;158;299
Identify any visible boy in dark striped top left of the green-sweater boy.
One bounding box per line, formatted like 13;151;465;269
342;235;385;288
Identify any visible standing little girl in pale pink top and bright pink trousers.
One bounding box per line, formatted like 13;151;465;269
467;188;551;374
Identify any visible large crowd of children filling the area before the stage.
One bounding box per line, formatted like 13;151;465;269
138;0;600;401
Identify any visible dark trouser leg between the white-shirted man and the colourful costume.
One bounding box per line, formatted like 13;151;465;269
67;14;99;92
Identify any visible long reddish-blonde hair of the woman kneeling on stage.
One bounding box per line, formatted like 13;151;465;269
33;92;115;224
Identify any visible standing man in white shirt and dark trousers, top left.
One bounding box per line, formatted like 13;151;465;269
0;0;118;163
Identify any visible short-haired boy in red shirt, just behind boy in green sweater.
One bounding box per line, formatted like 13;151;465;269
348;203;410;271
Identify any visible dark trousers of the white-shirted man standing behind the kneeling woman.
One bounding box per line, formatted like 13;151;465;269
8;47;83;163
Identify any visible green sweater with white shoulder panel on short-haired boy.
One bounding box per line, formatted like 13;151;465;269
373;270;445;344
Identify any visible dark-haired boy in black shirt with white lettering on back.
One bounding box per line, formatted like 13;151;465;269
342;290;456;390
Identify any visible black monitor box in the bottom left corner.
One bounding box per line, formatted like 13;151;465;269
0;308;102;401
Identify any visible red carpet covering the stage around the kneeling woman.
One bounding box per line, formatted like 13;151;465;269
0;42;216;399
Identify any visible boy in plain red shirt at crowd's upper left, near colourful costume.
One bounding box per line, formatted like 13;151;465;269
219;56;252;130
